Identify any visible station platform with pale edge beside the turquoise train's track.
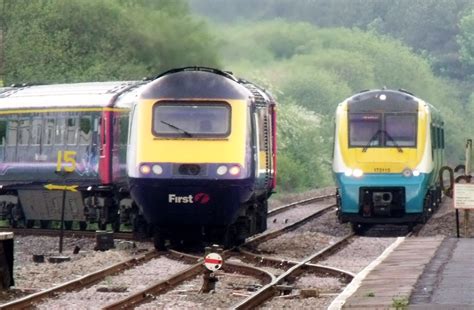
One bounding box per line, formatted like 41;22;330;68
329;237;474;309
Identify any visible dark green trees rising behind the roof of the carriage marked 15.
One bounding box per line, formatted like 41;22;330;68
4;0;217;83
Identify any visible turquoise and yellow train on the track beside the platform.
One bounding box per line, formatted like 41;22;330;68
333;89;444;226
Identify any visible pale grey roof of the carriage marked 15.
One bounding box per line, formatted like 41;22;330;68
0;81;146;110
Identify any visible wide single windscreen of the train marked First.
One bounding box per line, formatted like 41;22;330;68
153;102;231;138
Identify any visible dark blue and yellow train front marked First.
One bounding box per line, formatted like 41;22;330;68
127;67;276;248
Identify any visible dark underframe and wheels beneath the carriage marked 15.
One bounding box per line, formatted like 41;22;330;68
0;187;144;232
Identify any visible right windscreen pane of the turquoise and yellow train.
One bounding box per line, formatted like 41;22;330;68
385;114;416;147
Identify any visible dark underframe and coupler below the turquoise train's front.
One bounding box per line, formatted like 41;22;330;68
336;186;442;232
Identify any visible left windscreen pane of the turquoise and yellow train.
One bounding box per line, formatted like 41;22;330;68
349;113;382;147
